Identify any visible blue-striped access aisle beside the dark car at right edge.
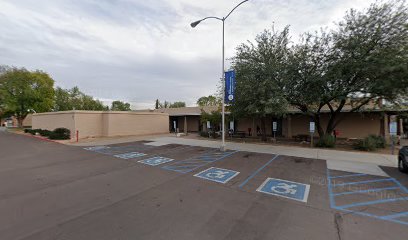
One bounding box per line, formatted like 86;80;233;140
327;169;408;225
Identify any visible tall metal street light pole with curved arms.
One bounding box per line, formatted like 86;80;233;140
190;0;249;151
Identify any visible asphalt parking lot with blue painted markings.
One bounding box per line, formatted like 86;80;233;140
0;132;408;240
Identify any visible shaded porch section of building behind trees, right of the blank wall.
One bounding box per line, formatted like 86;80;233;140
144;105;404;139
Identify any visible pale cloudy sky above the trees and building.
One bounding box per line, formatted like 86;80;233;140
0;0;374;109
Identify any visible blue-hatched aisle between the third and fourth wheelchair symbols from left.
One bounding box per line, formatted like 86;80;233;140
162;150;237;173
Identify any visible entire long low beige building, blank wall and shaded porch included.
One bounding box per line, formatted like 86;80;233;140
28;107;404;139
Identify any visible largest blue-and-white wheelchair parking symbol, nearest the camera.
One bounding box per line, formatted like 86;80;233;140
256;178;310;202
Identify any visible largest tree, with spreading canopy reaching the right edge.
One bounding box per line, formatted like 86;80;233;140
285;2;408;137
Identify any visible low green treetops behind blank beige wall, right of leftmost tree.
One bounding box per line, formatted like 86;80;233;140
54;87;109;111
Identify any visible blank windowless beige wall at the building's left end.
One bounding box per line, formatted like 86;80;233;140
32;111;169;138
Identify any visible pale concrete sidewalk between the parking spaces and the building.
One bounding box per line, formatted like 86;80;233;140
149;137;398;167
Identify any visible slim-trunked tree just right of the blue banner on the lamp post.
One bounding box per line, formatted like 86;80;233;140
231;27;289;141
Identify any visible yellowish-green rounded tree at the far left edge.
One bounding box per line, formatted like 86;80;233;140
0;68;54;127
